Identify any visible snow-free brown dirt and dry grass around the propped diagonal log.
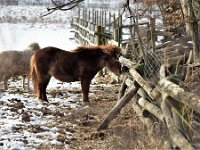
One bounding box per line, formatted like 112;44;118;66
61;77;169;149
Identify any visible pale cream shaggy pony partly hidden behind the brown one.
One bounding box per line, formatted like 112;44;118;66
0;43;40;90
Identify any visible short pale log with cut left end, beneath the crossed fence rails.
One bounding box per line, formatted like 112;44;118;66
138;97;164;122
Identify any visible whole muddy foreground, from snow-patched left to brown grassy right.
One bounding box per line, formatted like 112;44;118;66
0;76;169;149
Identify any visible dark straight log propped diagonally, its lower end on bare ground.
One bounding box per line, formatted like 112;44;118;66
97;85;138;131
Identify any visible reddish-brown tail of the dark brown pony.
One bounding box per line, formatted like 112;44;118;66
30;54;38;95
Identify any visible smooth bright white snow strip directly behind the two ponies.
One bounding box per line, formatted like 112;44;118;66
0;23;77;51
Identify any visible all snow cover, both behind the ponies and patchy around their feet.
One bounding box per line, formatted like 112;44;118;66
0;6;94;150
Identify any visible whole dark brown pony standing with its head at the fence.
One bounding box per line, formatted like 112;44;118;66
30;45;121;103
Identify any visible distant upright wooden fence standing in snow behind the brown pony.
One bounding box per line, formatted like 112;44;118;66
72;9;152;45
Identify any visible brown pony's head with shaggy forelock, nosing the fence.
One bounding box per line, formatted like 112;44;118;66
102;45;121;75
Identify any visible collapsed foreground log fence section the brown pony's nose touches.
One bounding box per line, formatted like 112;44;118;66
97;57;200;149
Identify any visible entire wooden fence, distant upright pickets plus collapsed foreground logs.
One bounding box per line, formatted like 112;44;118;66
73;7;200;149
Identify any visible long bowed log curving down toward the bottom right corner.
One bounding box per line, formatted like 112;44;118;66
161;95;193;150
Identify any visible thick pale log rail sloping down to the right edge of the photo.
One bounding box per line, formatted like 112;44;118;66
158;79;200;113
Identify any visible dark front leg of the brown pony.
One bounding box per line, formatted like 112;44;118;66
81;79;91;104
